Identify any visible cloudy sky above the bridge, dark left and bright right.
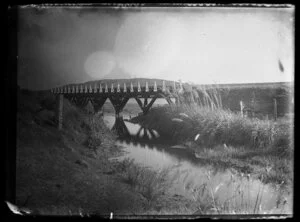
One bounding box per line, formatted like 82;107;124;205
18;6;294;90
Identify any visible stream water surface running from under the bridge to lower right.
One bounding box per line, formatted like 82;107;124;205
104;116;292;213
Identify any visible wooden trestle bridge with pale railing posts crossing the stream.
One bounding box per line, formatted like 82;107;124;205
51;79;188;128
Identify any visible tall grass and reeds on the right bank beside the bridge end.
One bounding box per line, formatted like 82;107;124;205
140;85;292;154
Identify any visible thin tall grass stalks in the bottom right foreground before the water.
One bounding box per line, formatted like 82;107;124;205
187;171;291;215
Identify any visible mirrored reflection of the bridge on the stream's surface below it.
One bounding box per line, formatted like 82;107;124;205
106;117;234;172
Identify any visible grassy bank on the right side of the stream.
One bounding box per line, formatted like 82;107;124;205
131;106;293;186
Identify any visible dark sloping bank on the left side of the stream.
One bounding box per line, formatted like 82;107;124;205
16;91;197;217
